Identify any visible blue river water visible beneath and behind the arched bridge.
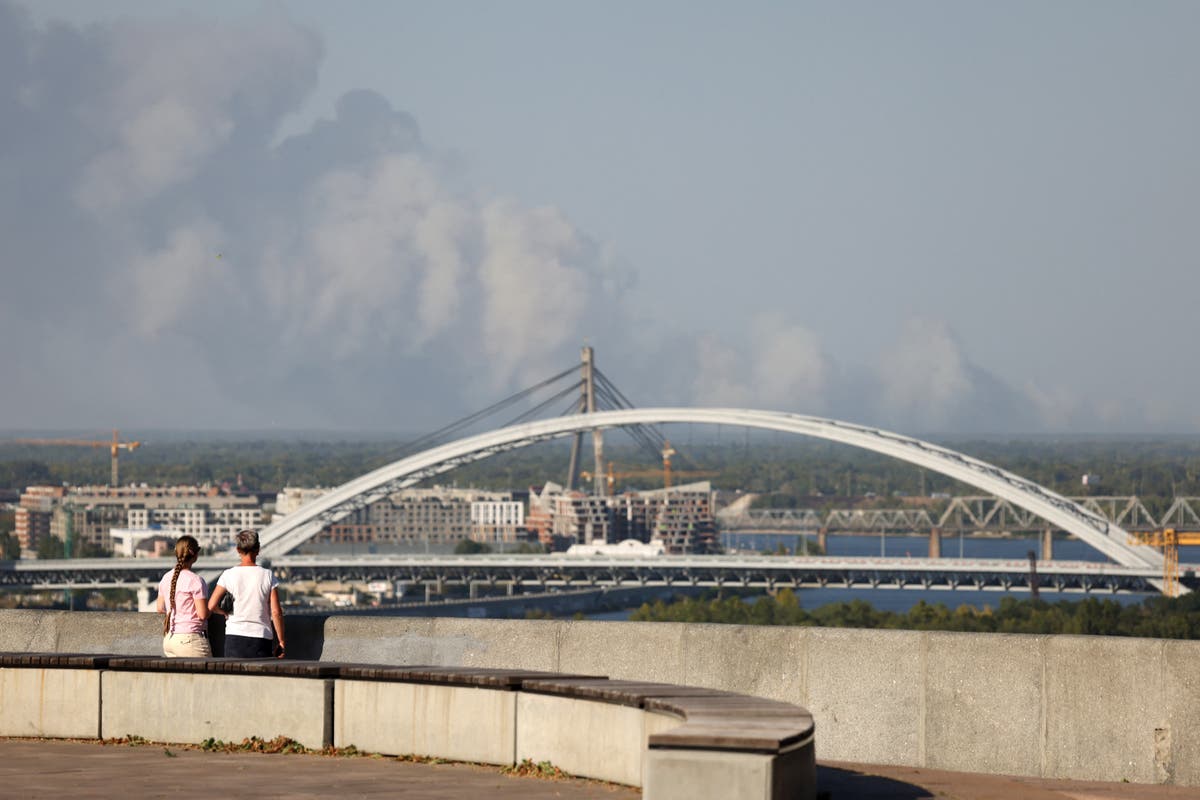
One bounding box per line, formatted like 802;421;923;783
588;534;1200;620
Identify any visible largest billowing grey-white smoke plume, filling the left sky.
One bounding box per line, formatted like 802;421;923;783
0;0;625;429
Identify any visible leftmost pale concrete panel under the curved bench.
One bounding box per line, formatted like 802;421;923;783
0;668;100;739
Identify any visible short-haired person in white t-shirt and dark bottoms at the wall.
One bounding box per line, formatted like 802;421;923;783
209;530;284;658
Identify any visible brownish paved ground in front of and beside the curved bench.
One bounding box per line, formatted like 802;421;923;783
0;739;1200;800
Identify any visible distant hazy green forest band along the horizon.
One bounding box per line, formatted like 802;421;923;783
7;434;1200;503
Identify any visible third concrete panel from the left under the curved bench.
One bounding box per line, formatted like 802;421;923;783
334;680;513;774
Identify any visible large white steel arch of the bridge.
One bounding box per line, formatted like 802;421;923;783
260;408;1162;566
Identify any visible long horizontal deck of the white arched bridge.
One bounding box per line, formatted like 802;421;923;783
0;555;1180;593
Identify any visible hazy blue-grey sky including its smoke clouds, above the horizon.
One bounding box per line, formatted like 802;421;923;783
0;0;1200;433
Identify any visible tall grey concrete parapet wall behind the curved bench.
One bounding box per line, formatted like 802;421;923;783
7;610;1200;786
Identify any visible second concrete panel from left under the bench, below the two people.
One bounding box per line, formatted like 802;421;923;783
99;670;329;748
